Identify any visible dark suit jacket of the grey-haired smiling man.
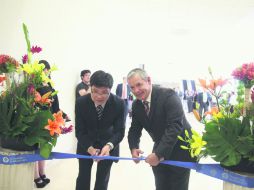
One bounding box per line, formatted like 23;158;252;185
128;86;194;161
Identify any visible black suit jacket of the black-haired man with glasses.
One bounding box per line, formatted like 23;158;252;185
75;94;125;156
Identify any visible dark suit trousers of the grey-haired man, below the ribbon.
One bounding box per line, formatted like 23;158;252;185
152;164;190;190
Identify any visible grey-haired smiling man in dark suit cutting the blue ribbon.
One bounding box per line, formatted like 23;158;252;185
127;69;193;190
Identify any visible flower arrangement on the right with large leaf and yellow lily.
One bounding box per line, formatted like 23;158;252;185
179;64;254;173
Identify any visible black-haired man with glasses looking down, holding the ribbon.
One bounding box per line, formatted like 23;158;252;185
75;71;125;190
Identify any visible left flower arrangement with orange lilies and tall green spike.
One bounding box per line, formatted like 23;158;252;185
0;24;72;158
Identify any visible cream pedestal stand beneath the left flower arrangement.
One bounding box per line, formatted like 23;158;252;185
0;147;35;190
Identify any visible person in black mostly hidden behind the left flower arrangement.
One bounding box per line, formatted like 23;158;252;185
34;60;70;188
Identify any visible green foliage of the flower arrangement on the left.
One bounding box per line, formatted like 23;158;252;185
0;79;56;157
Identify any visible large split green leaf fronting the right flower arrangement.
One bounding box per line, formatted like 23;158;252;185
203;118;243;166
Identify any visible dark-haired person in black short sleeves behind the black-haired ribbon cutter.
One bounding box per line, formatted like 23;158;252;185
76;70;91;99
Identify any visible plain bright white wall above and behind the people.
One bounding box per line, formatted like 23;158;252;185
0;0;254;150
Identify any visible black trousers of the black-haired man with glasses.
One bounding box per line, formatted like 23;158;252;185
76;159;113;190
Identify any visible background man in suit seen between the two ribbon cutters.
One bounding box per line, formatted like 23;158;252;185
116;77;131;117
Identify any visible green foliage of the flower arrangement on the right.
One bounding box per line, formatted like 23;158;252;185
203;117;254;166
